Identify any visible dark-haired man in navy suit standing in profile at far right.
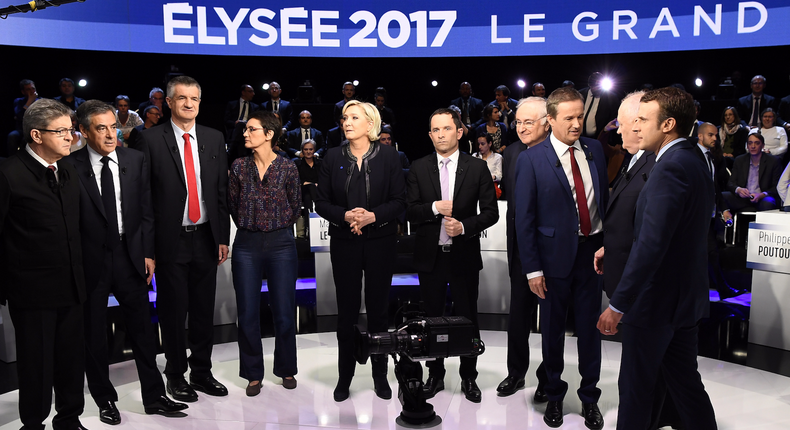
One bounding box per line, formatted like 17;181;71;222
598;87;717;430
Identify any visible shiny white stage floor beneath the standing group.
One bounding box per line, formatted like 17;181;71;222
0;331;790;430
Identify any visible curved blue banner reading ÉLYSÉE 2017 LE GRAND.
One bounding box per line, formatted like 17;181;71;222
0;0;790;57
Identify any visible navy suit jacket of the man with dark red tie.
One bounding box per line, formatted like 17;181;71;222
515;135;609;278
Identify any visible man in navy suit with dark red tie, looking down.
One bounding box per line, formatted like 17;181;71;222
515;88;609;429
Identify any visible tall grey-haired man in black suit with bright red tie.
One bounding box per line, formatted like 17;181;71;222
141;76;230;402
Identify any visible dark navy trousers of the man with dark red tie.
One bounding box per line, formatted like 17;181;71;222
539;234;603;403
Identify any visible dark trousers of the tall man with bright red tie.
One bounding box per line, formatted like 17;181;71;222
156;223;219;379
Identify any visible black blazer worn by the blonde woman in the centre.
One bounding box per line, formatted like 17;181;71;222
315;141;406;238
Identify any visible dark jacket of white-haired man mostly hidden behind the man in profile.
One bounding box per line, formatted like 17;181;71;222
603;152;656;297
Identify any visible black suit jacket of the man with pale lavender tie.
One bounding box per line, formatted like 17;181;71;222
406;152;499;272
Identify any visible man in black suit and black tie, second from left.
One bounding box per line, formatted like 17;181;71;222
65;100;187;425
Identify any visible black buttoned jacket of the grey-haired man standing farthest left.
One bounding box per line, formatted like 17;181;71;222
0;148;85;309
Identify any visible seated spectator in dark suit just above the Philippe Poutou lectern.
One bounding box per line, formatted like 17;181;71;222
722;130;781;212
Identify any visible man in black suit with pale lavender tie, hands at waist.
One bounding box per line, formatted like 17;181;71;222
406;108;499;403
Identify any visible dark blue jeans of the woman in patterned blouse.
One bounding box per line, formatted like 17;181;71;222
231;228;297;381
